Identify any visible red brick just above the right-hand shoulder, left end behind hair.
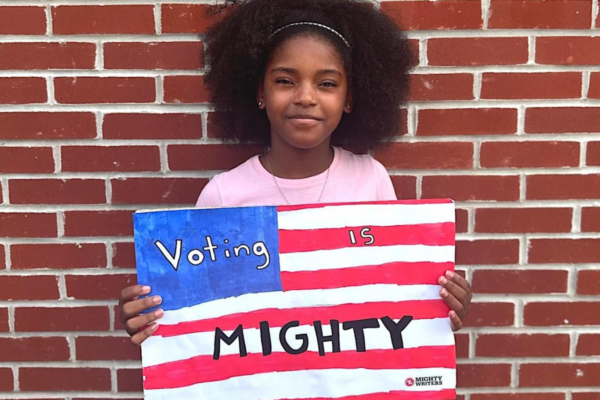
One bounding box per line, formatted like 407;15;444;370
375;142;474;169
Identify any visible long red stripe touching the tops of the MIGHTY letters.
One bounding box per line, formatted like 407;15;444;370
154;300;449;337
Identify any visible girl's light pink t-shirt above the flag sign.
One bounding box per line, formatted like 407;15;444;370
196;147;396;207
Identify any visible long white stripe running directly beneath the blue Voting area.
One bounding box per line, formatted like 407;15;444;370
157;284;441;325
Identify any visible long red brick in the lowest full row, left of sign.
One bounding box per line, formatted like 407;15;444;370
19;367;111;392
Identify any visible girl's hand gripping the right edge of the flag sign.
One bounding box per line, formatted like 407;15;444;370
438;271;473;332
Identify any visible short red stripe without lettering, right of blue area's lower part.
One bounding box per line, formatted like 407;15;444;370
281;262;454;291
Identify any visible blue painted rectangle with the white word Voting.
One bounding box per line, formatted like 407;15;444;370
134;207;282;310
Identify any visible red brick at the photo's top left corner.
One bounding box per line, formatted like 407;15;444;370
0;6;46;35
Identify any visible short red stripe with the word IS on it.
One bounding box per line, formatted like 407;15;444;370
279;222;454;253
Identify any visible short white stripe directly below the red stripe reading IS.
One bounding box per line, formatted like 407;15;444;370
279;244;454;272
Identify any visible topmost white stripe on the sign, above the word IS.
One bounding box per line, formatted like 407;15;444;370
277;203;455;229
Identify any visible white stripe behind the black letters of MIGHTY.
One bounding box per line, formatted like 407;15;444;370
142;318;454;367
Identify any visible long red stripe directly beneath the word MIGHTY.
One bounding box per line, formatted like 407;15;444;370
143;346;456;390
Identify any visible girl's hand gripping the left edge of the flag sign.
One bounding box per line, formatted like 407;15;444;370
119;285;164;346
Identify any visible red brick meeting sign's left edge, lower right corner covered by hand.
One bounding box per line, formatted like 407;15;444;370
65;274;137;300
